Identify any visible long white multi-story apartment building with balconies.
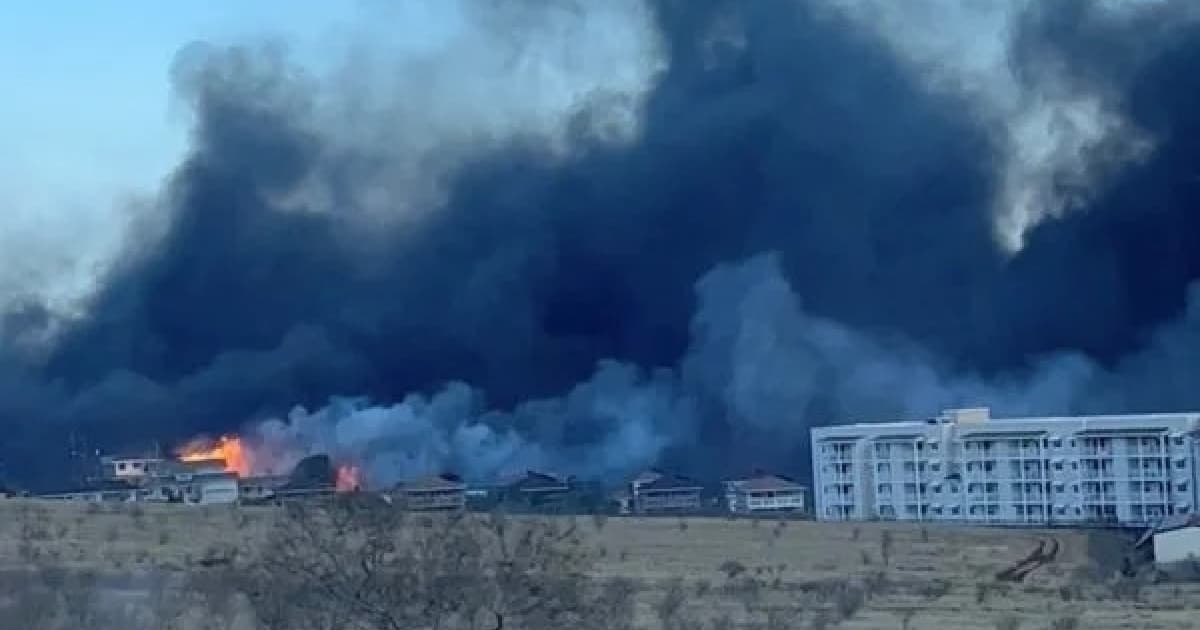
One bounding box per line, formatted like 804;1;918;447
812;408;1200;526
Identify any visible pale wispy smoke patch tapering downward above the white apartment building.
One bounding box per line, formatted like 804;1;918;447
835;0;1162;252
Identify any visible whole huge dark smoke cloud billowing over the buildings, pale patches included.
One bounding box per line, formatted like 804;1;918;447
0;0;1200;487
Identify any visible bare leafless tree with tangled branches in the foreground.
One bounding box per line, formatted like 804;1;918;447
236;497;632;630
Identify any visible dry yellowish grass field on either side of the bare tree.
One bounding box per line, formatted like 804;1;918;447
0;500;1200;630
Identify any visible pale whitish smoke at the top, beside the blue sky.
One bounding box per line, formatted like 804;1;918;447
255;0;667;222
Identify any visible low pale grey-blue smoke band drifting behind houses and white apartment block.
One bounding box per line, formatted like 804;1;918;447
236;254;1200;485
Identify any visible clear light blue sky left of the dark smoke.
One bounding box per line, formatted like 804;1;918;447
0;0;362;309
